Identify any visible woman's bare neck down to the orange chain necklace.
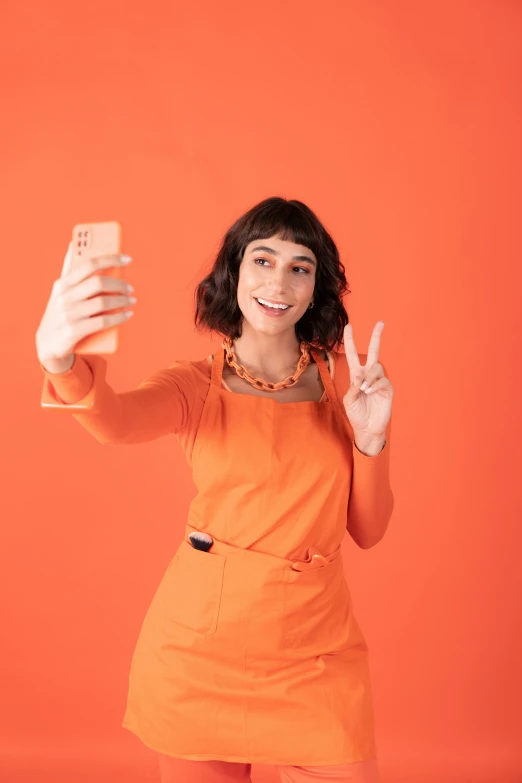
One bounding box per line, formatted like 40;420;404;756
228;327;312;383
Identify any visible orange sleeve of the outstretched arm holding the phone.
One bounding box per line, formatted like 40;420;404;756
40;354;196;445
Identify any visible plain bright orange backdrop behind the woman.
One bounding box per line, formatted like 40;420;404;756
0;0;522;783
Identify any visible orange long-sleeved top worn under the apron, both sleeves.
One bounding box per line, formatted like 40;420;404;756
40;351;394;548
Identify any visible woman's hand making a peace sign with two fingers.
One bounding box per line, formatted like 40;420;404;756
343;321;394;439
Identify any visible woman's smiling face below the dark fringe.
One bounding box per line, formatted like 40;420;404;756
237;236;317;334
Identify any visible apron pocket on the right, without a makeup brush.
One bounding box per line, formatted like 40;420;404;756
282;557;350;652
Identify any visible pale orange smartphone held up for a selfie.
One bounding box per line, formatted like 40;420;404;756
70;220;125;354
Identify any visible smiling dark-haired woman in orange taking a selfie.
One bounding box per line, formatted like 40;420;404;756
36;198;393;783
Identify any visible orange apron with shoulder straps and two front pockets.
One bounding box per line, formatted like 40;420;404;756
122;349;376;765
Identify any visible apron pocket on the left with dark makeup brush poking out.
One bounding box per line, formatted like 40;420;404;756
163;540;226;639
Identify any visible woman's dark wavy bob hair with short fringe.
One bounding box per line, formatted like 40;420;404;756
194;196;351;351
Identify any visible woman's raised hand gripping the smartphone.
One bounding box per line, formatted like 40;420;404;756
36;243;136;373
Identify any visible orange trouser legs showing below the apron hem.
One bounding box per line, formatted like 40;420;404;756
158;753;379;783
